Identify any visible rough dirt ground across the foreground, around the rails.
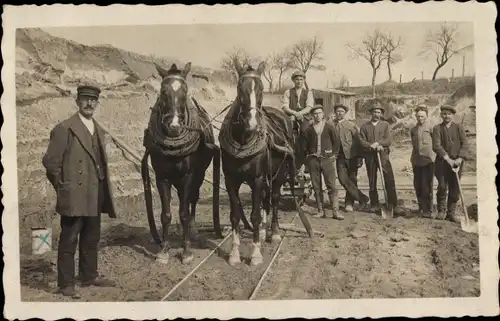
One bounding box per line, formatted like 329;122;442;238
21;185;480;301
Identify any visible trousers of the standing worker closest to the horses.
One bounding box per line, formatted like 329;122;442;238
307;156;337;209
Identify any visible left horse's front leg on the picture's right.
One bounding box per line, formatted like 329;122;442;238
177;174;194;264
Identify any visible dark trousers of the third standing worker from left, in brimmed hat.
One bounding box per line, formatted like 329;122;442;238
365;150;398;207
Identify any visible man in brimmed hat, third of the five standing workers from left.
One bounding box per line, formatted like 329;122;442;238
359;102;400;214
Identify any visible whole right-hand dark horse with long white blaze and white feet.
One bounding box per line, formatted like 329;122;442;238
219;60;295;265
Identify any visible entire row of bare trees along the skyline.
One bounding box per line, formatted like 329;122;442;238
221;23;459;96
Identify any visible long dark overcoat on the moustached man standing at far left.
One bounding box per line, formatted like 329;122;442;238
42;113;116;218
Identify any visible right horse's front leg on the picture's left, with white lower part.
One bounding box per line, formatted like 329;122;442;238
224;176;243;266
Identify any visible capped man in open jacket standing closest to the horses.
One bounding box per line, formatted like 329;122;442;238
305;105;344;220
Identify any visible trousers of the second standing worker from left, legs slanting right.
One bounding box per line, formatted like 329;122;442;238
337;153;368;206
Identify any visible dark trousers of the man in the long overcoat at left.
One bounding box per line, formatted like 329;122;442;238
57;182;103;288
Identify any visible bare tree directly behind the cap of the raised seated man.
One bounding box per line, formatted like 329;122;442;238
288;37;326;87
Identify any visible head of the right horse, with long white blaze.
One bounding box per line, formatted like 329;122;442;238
234;60;265;132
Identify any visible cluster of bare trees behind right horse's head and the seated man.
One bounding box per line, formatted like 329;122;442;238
221;37;325;92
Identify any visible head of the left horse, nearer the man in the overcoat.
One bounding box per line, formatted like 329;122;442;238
155;62;191;136
